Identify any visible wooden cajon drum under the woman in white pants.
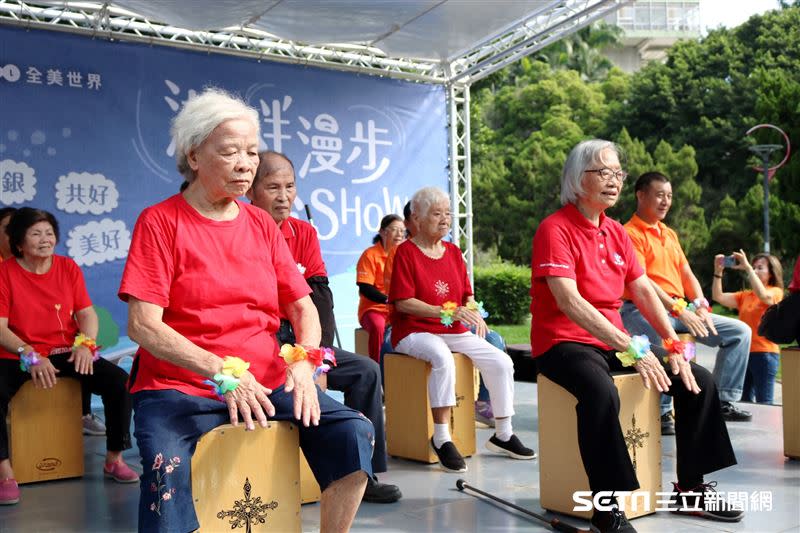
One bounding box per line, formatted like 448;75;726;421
383;353;476;463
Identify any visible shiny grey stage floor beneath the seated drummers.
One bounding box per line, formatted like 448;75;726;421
0;354;800;533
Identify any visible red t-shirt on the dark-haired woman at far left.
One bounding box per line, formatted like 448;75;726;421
0;255;92;359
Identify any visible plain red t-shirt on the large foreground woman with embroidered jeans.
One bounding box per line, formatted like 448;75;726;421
119;194;310;398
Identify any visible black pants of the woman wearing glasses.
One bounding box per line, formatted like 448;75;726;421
536;342;736;492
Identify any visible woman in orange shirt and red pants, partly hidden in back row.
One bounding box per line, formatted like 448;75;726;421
356;214;406;364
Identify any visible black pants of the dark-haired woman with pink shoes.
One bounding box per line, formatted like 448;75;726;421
0;354;131;460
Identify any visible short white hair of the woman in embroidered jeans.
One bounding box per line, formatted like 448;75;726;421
170;87;260;182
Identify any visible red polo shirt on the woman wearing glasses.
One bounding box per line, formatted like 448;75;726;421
531;204;644;357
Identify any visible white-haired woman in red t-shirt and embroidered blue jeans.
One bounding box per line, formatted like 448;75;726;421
119;89;374;531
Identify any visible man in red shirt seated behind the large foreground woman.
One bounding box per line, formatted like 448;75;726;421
247;151;402;503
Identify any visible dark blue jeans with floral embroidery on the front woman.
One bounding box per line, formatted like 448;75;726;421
133;386;374;533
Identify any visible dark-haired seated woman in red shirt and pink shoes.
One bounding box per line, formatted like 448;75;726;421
0;207;139;504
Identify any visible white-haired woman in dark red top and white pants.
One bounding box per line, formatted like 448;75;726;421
389;187;536;472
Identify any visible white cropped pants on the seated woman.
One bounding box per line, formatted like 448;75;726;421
395;332;514;418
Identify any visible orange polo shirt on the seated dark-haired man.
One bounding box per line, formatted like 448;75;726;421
623;213;688;300
